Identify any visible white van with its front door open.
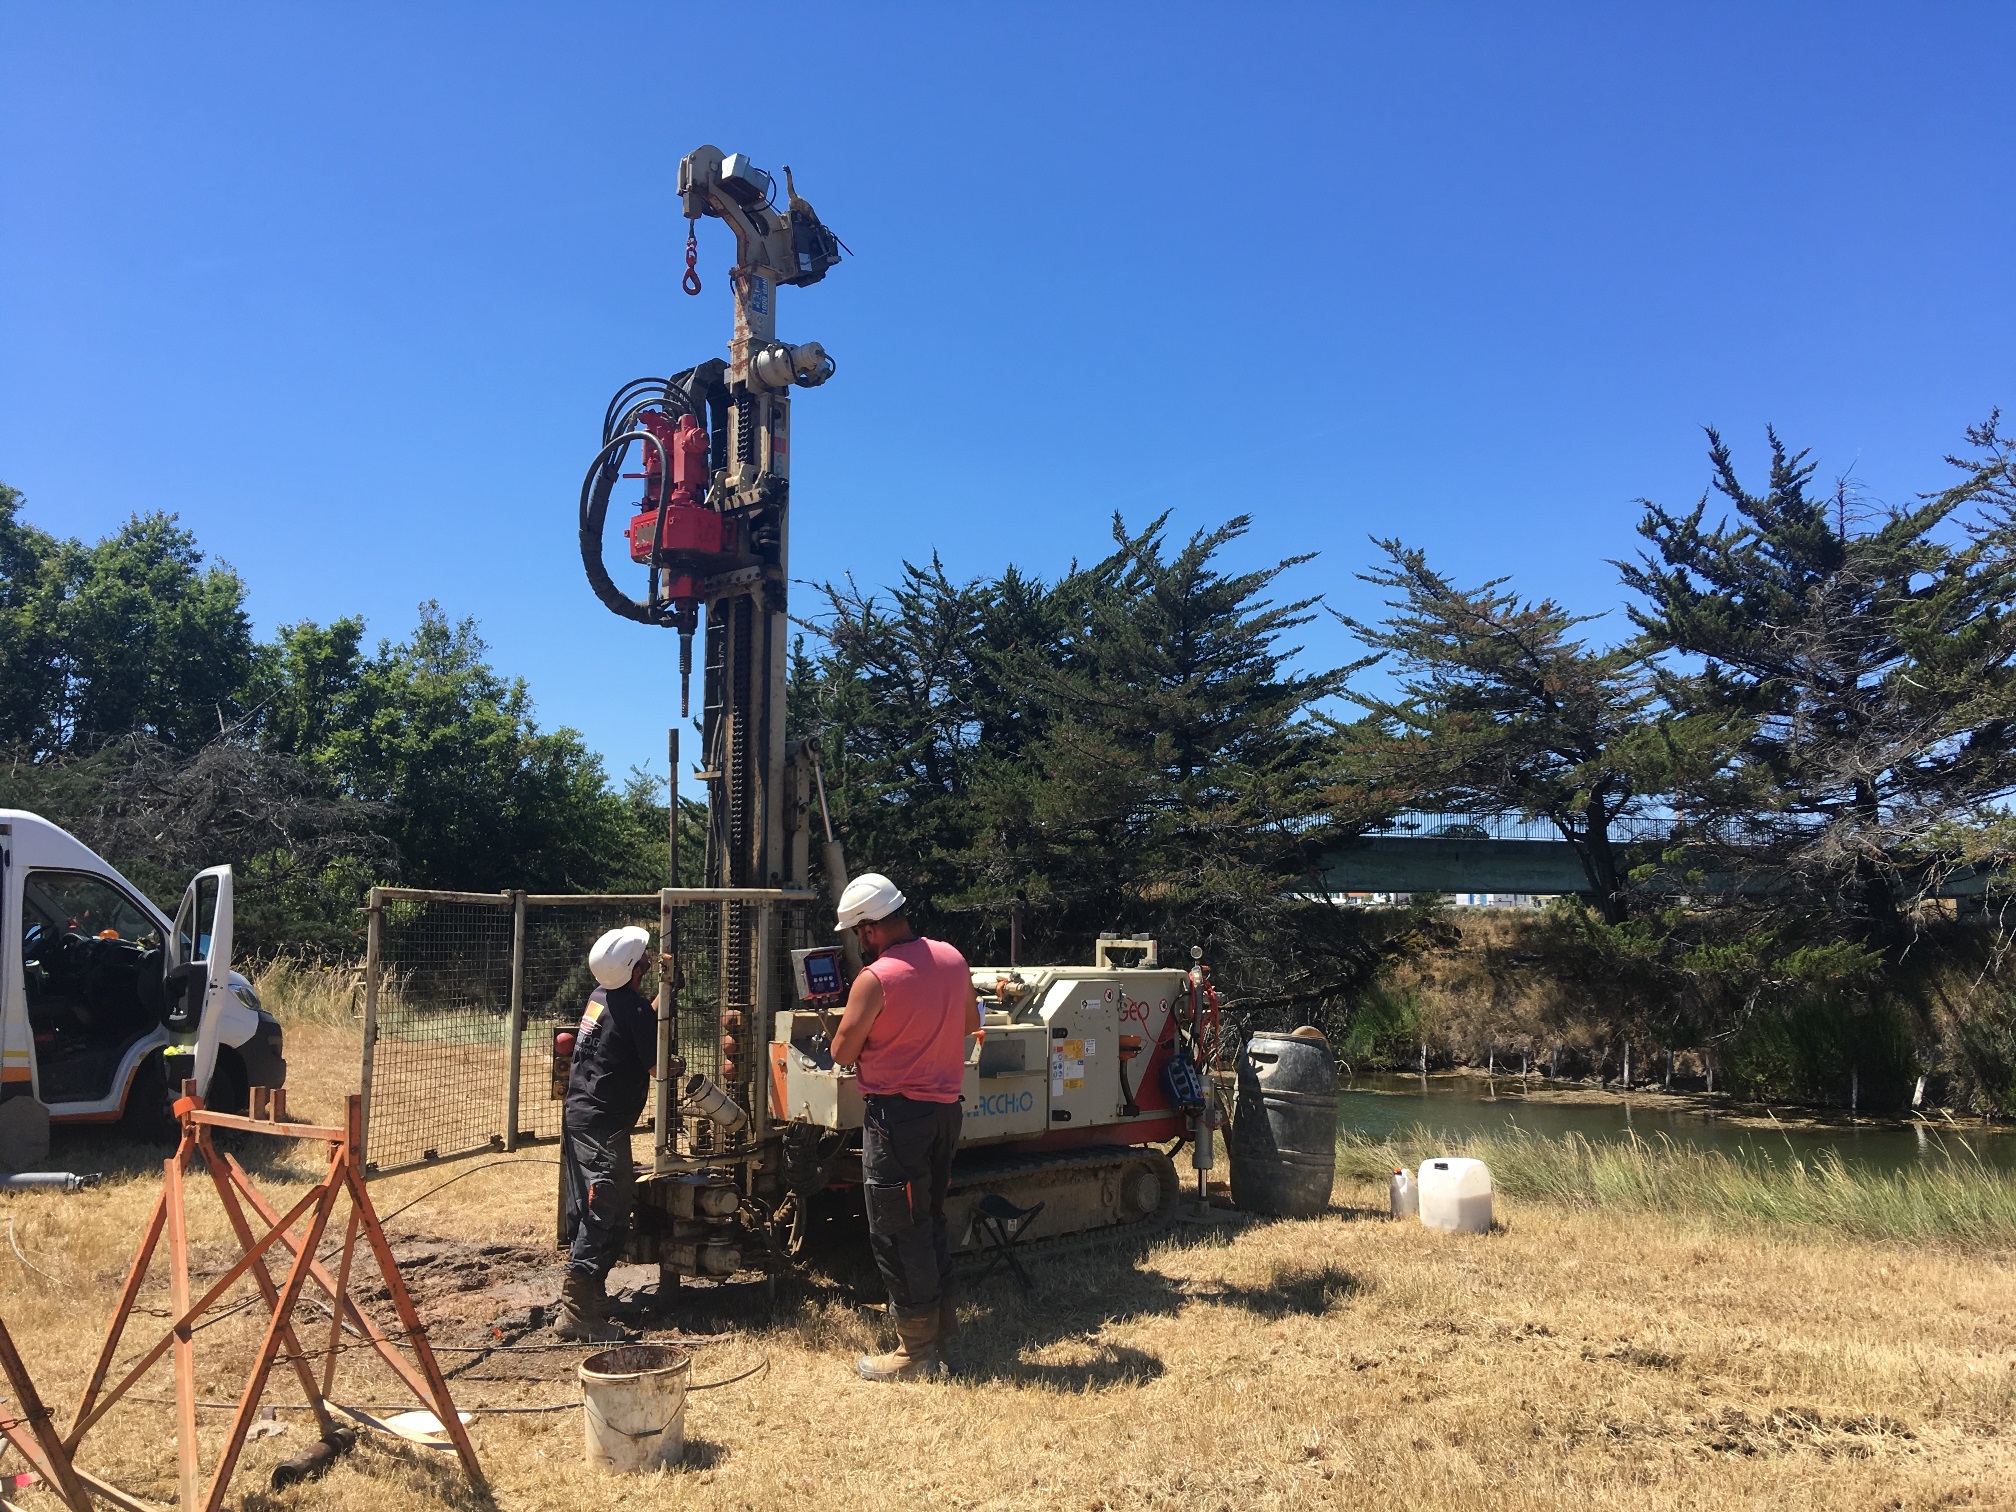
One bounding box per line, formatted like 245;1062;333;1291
0;808;286;1171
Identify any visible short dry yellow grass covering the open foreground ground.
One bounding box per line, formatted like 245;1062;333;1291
0;1026;2016;1512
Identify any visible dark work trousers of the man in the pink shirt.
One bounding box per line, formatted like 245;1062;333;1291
861;1097;960;1318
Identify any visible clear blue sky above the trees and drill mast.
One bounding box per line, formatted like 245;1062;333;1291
0;4;2016;774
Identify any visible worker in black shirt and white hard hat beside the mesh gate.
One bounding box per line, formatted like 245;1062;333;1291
556;925;657;1343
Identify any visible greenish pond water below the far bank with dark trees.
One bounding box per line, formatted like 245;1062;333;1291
1337;1073;2016;1171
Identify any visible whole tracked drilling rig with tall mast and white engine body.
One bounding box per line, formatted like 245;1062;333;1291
579;147;1224;1276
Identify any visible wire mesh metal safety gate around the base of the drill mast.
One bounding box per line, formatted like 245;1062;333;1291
363;887;812;1175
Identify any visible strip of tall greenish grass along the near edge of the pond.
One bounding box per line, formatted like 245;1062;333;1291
1339;1125;2016;1250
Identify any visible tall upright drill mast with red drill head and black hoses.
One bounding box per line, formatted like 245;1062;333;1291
581;147;841;1137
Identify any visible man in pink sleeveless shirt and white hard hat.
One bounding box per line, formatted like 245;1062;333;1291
833;871;980;1381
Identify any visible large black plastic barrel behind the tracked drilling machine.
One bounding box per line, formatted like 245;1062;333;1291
1232;1028;1337;1218
